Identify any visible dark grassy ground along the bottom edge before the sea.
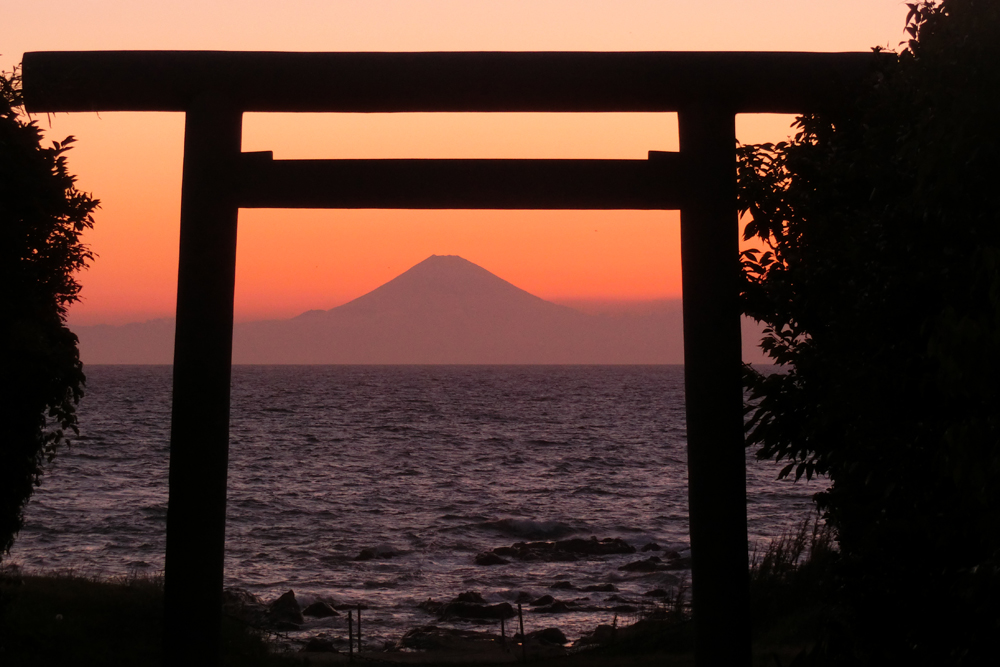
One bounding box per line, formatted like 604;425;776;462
0;522;835;667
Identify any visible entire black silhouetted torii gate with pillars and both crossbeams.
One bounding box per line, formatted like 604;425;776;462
23;51;875;667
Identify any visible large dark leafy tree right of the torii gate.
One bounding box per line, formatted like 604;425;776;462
738;0;1000;664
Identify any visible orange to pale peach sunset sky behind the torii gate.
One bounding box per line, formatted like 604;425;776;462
0;0;907;324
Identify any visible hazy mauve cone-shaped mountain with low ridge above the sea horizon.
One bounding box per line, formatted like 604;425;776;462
74;255;704;364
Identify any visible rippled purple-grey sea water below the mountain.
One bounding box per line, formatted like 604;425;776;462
11;366;823;643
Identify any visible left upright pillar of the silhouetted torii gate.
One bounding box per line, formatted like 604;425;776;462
163;94;242;667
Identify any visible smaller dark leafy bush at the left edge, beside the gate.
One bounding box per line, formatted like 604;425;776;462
0;70;99;558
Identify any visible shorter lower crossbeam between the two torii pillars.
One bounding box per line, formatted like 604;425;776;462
238;153;688;210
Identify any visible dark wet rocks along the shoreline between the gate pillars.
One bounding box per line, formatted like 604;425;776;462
223;537;690;658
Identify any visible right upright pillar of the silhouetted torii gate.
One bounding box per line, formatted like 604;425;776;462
678;103;751;667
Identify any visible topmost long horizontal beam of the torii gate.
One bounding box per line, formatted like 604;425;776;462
23;51;892;113
